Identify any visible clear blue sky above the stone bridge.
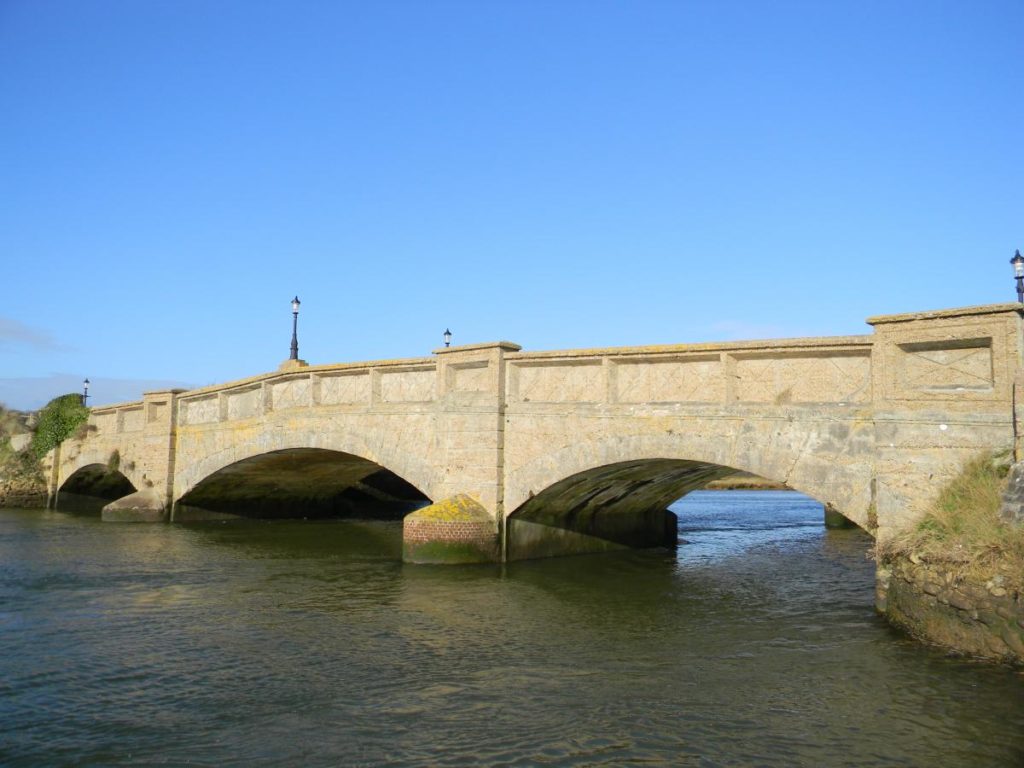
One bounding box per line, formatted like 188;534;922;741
0;0;1024;408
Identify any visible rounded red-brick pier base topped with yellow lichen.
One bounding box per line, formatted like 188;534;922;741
401;494;500;563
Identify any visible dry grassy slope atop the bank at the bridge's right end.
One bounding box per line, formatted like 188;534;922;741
879;454;1024;590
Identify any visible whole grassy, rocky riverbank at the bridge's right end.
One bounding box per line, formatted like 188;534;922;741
876;456;1024;666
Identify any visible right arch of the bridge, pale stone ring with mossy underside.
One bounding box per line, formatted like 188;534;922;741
506;434;871;559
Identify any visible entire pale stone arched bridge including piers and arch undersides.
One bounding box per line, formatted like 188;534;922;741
49;304;1024;561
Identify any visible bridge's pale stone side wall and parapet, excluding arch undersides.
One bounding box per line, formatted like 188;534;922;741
49;304;1022;561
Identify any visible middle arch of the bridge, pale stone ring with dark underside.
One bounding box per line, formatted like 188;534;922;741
174;430;434;519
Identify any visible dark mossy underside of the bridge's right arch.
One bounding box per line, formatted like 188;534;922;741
508;459;839;560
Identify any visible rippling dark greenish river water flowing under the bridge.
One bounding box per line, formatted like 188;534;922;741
0;492;1024;768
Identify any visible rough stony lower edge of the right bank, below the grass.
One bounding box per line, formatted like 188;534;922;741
877;557;1024;665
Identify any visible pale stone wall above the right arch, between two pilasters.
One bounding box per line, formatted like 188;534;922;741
505;337;874;528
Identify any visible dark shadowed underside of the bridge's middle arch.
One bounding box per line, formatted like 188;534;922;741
173;447;429;520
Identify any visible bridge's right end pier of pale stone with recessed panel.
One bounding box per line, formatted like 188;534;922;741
868;304;1022;540
